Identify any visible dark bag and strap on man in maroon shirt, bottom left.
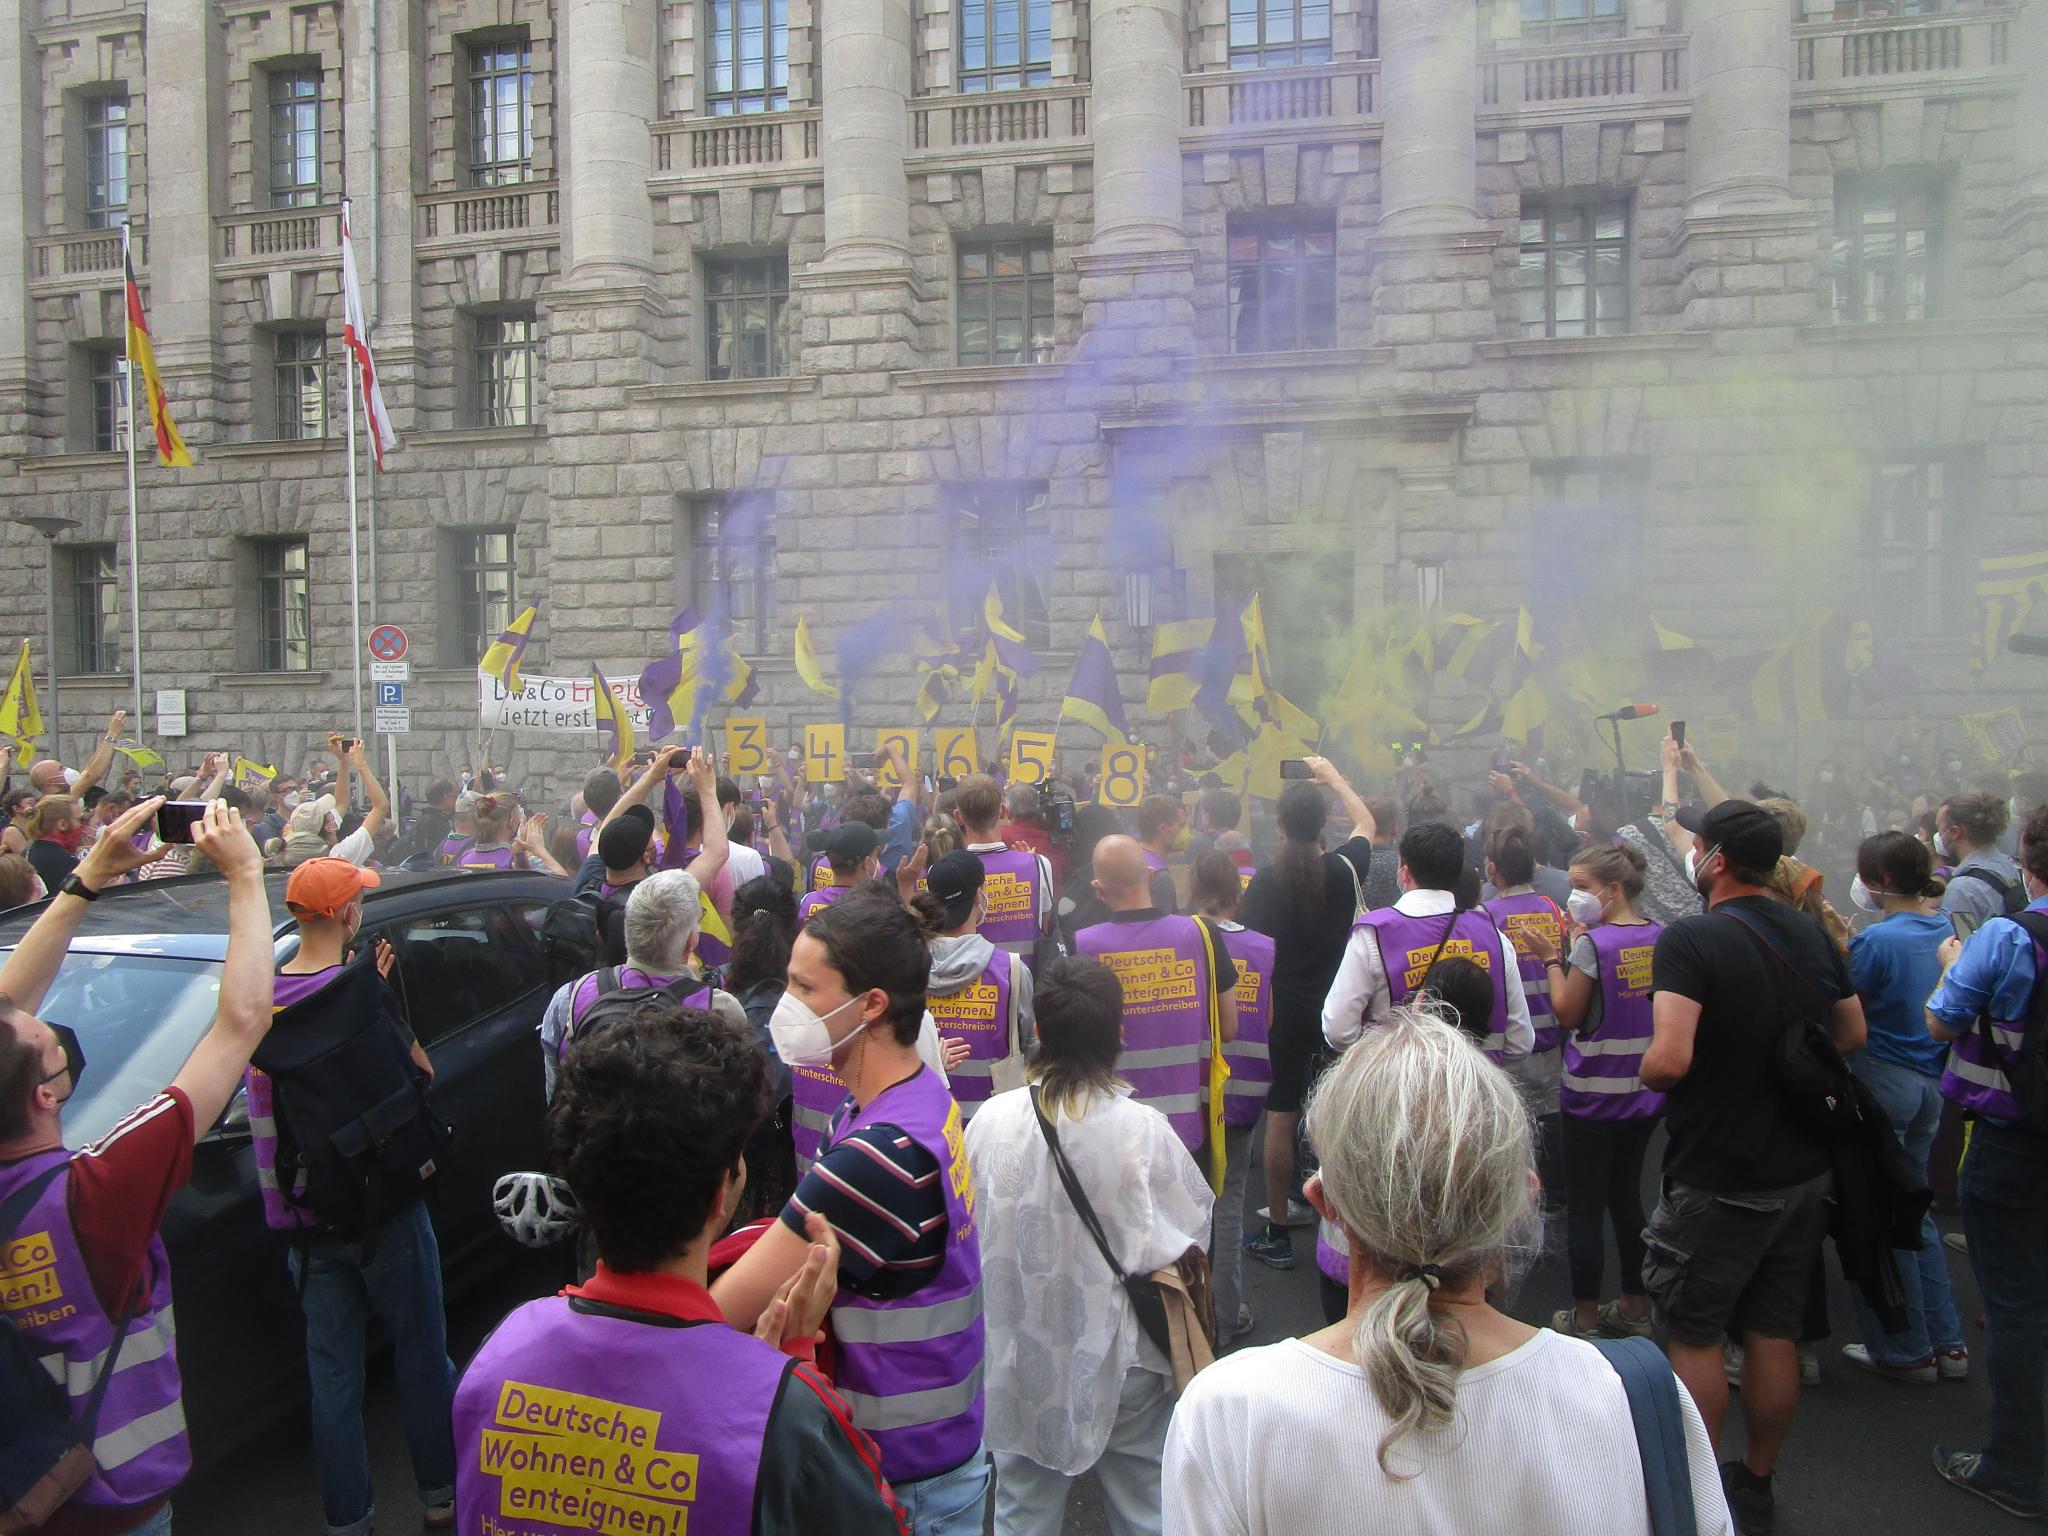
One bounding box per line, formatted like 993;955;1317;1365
0;1163;131;1530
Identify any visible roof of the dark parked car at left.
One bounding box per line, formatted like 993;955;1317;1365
0;868;569;961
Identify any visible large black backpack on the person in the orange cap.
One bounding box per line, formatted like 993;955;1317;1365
252;954;449;1243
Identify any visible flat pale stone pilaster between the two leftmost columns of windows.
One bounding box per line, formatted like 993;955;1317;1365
143;6;227;428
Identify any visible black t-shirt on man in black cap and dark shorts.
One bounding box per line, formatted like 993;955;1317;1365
1651;897;1855;1192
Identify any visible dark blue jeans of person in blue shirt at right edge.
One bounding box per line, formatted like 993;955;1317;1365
1958;1118;2048;1497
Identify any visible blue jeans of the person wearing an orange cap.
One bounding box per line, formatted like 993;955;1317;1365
291;1202;455;1536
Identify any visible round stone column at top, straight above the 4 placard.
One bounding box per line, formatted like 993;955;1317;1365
817;0;911;270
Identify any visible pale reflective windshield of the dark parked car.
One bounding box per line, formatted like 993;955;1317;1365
24;950;221;1147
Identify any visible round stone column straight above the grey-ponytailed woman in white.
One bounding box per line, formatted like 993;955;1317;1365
1380;0;1479;236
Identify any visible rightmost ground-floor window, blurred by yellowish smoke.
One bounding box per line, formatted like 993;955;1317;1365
1868;459;1982;639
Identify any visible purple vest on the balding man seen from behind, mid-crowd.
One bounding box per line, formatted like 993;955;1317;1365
1073;915;1217;1151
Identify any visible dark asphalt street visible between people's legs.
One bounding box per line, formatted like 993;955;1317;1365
174;1153;2021;1536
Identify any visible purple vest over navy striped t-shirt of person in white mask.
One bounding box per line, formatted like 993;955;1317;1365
831;1067;985;1483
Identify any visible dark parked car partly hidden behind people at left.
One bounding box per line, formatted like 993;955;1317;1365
0;870;567;1462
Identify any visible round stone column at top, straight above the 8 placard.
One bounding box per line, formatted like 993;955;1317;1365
1090;0;1186;254
